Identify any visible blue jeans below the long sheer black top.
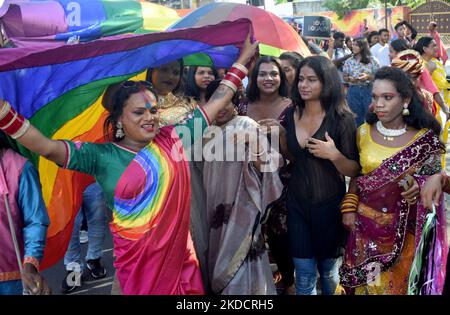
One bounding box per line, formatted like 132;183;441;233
293;257;339;295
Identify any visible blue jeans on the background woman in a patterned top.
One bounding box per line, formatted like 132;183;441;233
347;84;372;127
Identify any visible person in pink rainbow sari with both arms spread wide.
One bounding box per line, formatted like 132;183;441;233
0;39;257;294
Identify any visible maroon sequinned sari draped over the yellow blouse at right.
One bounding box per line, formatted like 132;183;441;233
340;130;447;294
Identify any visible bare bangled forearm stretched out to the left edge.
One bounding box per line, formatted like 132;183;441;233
0;100;66;165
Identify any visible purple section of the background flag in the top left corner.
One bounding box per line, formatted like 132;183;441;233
2;1;67;38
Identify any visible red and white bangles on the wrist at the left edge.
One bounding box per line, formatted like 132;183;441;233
0;101;30;139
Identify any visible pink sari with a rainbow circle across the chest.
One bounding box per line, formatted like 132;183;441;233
111;127;204;295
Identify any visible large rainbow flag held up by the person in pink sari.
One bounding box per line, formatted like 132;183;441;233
0;19;253;268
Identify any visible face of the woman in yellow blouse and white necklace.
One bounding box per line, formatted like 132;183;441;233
372;80;410;124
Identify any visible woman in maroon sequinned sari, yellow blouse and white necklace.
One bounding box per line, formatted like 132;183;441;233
340;67;447;294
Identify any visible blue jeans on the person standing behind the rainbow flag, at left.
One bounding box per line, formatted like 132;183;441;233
64;183;107;269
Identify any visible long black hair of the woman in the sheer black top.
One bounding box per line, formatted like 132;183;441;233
291;56;352;122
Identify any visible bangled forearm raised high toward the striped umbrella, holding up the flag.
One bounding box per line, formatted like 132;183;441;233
202;36;258;121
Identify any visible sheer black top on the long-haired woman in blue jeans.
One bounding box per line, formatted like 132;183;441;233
285;107;359;259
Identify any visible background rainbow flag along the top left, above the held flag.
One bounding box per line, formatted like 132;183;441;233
0;0;180;46
